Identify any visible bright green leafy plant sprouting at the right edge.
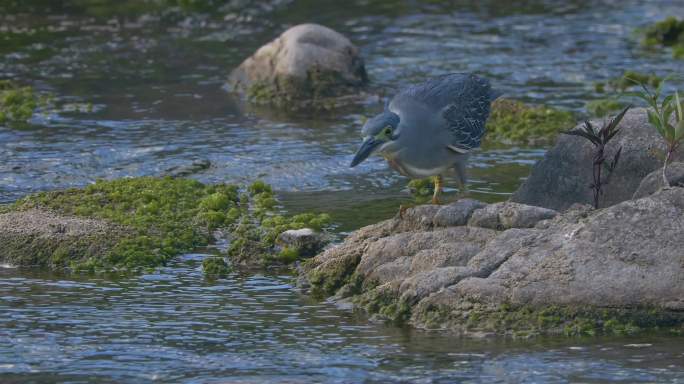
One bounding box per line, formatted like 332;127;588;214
627;80;684;187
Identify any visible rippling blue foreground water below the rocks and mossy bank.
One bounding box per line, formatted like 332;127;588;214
0;254;684;383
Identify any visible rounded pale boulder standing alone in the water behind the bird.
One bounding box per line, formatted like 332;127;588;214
228;24;368;105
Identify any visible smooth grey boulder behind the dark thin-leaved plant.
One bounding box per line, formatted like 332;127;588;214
511;108;684;211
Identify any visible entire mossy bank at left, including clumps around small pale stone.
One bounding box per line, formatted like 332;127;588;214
2;177;329;270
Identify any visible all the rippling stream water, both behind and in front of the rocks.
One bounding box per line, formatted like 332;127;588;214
0;0;684;383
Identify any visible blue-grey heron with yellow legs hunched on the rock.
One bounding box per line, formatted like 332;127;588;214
351;73;497;202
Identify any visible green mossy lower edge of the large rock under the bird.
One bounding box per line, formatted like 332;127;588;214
307;258;684;338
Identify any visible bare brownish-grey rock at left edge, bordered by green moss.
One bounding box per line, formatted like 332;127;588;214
0;209;127;268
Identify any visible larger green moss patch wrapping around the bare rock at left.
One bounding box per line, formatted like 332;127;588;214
7;177;237;270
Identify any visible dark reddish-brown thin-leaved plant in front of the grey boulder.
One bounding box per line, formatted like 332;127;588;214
563;106;630;208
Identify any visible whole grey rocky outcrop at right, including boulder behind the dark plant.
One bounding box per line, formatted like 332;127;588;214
299;109;684;336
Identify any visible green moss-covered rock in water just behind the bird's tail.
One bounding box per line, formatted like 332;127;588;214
485;99;576;145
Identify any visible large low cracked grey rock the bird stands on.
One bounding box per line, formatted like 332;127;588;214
300;188;684;335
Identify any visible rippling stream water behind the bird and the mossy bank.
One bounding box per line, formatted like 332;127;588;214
0;0;681;228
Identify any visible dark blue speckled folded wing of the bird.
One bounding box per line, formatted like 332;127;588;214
392;73;498;153
